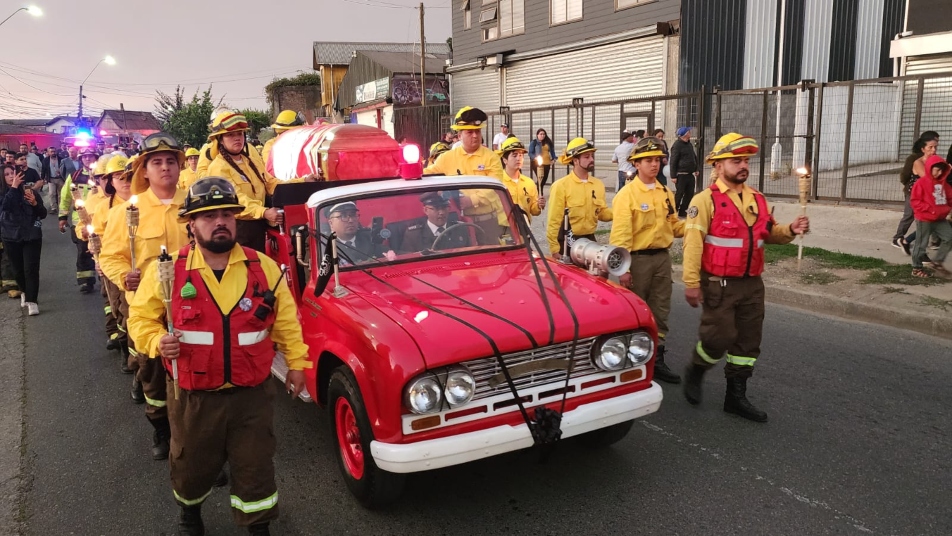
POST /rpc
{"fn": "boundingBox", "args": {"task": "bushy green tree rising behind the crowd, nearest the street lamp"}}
[155,86,221,147]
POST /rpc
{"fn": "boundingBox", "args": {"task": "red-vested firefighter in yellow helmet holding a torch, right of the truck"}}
[684,132,810,422]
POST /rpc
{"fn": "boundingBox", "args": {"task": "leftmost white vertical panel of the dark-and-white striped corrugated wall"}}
[744,1,777,88]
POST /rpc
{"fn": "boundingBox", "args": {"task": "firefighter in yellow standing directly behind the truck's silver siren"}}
[546,138,612,259]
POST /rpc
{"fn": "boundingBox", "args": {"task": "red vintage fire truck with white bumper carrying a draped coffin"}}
[267,124,662,507]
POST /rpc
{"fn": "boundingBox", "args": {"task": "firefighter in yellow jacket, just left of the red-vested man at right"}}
[608,138,684,383]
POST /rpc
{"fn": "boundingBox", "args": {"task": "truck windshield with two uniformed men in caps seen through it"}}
[317,188,524,268]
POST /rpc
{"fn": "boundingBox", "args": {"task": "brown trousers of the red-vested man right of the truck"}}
[692,273,764,378]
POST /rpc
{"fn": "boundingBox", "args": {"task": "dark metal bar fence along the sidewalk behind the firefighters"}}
[442,73,952,203]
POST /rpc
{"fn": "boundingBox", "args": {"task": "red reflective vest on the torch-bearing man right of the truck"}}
[701,183,773,277]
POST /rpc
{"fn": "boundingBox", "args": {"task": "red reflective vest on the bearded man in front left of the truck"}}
[167,246,275,391]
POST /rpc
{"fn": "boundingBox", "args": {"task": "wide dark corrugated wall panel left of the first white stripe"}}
[678,0,747,93]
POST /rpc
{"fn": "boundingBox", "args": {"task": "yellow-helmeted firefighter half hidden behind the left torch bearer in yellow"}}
[93,155,139,376]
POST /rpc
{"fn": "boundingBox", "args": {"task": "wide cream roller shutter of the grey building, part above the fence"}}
[505,36,665,110]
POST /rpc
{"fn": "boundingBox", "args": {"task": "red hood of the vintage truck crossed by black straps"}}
[341,251,653,368]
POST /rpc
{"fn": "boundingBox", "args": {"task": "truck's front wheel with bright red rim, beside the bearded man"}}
[327,367,406,508]
